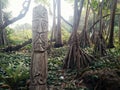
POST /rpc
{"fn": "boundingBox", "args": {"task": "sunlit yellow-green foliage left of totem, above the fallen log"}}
[7,25,32,45]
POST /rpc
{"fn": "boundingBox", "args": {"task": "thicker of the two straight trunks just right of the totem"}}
[55,0,63,47]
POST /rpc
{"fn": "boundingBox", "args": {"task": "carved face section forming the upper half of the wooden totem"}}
[32,5,48,51]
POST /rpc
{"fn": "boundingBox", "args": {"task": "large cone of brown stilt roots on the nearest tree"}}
[63,40,94,70]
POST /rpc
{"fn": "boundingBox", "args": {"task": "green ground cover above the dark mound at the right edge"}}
[91,48,120,69]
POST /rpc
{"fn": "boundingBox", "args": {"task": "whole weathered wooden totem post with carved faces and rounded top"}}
[29,5,48,90]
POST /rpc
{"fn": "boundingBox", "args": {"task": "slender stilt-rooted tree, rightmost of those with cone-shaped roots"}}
[94,1,107,56]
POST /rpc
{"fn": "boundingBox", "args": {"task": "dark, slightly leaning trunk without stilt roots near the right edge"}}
[107,0,117,48]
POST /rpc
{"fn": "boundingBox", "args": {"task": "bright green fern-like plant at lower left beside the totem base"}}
[1,62,29,90]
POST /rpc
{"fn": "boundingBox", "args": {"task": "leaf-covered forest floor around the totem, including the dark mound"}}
[0,47,120,90]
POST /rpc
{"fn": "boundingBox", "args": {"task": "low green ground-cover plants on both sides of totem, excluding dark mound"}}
[0,46,120,90]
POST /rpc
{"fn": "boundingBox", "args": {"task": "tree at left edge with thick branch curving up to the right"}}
[0,0,31,45]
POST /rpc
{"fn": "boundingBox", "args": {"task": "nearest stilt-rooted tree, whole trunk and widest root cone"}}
[63,0,94,70]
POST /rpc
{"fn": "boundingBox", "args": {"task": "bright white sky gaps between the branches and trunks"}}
[8,0,73,27]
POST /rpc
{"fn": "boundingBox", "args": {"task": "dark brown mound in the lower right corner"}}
[80,68,120,90]
